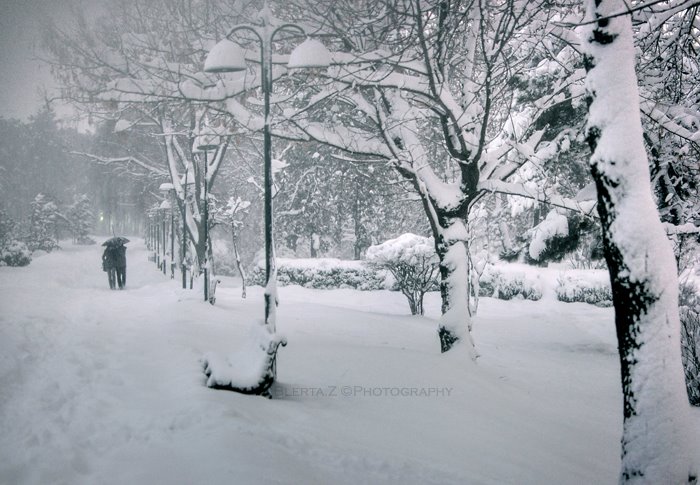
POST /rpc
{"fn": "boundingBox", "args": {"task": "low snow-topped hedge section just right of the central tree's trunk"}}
[479,265,542,301]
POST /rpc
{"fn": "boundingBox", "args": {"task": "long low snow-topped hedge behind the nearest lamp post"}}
[248,258,388,291]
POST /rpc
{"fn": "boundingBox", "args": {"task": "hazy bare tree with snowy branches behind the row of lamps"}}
[45,0,246,278]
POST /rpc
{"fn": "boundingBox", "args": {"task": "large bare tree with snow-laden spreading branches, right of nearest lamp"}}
[274,0,590,352]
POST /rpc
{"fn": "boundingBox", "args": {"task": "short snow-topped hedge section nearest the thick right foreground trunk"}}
[555,270,612,306]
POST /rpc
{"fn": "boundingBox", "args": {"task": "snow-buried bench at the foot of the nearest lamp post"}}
[202,325,287,398]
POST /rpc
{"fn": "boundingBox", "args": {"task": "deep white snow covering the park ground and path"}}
[0,237,688,484]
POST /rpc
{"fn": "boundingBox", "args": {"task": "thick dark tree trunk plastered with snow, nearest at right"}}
[583,0,698,484]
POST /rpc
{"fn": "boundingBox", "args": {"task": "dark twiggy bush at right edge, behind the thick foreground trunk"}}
[678,284,700,406]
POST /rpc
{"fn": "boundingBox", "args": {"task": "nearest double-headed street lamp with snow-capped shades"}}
[204,8,331,333]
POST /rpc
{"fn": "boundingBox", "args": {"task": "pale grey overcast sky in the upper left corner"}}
[0,0,102,120]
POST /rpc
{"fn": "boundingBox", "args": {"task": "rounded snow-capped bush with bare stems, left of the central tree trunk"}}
[367,233,439,315]
